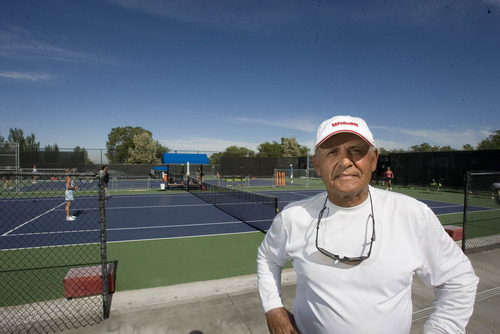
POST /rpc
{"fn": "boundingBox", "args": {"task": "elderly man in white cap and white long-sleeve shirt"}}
[257,116,478,334]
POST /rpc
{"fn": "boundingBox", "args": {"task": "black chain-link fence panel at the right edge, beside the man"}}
[462,172,500,253]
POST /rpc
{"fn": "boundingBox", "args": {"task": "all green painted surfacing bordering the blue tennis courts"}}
[0,183,499,306]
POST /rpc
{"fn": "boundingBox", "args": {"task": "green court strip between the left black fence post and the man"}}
[108,232,264,290]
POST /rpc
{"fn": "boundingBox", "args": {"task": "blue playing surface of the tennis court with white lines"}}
[0,190,487,249]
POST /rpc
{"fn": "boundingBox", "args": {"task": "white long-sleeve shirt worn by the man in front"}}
[257,187,478,334]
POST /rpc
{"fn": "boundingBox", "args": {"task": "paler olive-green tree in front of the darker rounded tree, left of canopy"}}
[125,131,161,165]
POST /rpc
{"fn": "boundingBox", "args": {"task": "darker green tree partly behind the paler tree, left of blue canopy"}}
[106,126,169,163]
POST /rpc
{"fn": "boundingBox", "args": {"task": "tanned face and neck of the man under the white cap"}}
[313,133,378,206]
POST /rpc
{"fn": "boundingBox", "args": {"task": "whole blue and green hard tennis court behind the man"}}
[0,180,494,334]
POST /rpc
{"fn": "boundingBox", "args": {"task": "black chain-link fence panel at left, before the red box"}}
[0,171,109,334]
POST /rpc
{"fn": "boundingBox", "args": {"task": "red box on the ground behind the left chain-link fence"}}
[64,263,115,299]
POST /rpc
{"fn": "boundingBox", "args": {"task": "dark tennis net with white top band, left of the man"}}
[188,177,279,233]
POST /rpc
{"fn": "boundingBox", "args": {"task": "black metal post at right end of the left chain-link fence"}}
[98,169,111,319]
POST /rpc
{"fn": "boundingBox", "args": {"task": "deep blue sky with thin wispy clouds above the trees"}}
[0,0,500,157]
